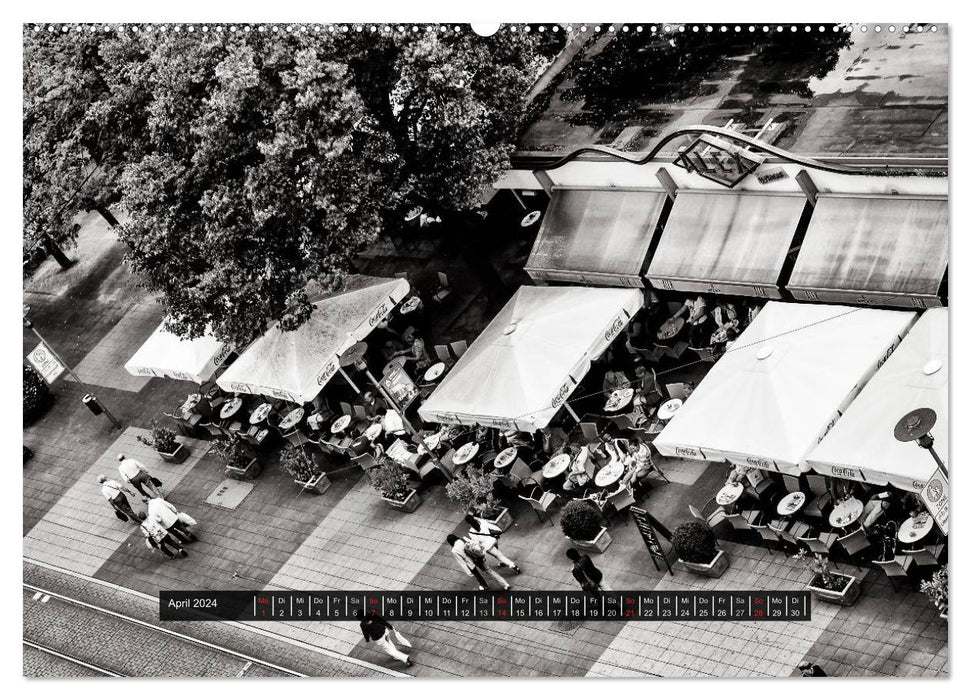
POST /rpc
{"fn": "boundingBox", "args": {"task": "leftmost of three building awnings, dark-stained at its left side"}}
[526,189,667,287]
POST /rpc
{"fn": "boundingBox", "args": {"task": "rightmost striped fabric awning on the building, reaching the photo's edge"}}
[786,195,948,308]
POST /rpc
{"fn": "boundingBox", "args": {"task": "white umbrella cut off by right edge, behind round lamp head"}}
[807,309,950,492]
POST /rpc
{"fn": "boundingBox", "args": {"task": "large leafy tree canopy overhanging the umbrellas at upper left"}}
[24,26,545,344]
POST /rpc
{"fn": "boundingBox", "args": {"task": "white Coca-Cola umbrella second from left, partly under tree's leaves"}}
[216,277,410,403]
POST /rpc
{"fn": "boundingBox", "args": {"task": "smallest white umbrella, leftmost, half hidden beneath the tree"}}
[125,321,233,384]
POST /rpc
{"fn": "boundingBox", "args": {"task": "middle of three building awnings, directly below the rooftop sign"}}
[647,191,807,299]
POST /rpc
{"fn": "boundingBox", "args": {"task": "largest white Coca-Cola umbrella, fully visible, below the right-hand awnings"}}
[654,302,916,475]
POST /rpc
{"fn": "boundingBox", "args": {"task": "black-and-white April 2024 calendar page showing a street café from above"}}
[19,5,962,684]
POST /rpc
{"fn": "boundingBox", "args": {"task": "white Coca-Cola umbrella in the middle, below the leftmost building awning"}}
[418,287,644,432]
